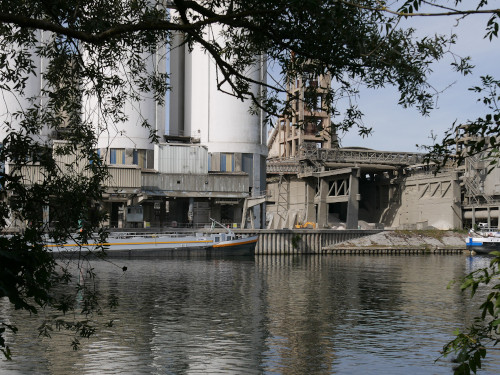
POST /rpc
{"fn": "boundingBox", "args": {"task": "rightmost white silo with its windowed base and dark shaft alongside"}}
[169,26,267,228]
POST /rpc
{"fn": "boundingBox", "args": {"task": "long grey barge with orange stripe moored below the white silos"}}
[45,220,258,257]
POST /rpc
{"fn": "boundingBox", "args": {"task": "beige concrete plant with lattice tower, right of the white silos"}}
[266,77,492,229]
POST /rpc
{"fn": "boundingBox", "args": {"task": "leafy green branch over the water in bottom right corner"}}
[442,252,500,375]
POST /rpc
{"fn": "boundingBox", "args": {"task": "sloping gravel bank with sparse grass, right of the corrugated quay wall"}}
[322,230,468,254]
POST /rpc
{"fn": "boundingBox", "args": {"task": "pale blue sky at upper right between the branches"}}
[340,11,500,152]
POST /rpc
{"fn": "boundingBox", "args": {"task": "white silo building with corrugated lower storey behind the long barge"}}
[0,26,267,228]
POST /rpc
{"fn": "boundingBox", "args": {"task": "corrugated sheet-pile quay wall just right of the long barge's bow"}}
[234,229,382,255]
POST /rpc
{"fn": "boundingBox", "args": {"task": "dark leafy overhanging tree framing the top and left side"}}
[0,0,498,364]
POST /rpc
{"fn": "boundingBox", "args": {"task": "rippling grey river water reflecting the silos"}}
[0,255,500,374]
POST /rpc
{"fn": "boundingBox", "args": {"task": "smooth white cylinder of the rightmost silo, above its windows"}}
[184,37,267,156]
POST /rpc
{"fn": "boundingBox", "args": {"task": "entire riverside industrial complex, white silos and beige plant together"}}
[0,29,500,234]
